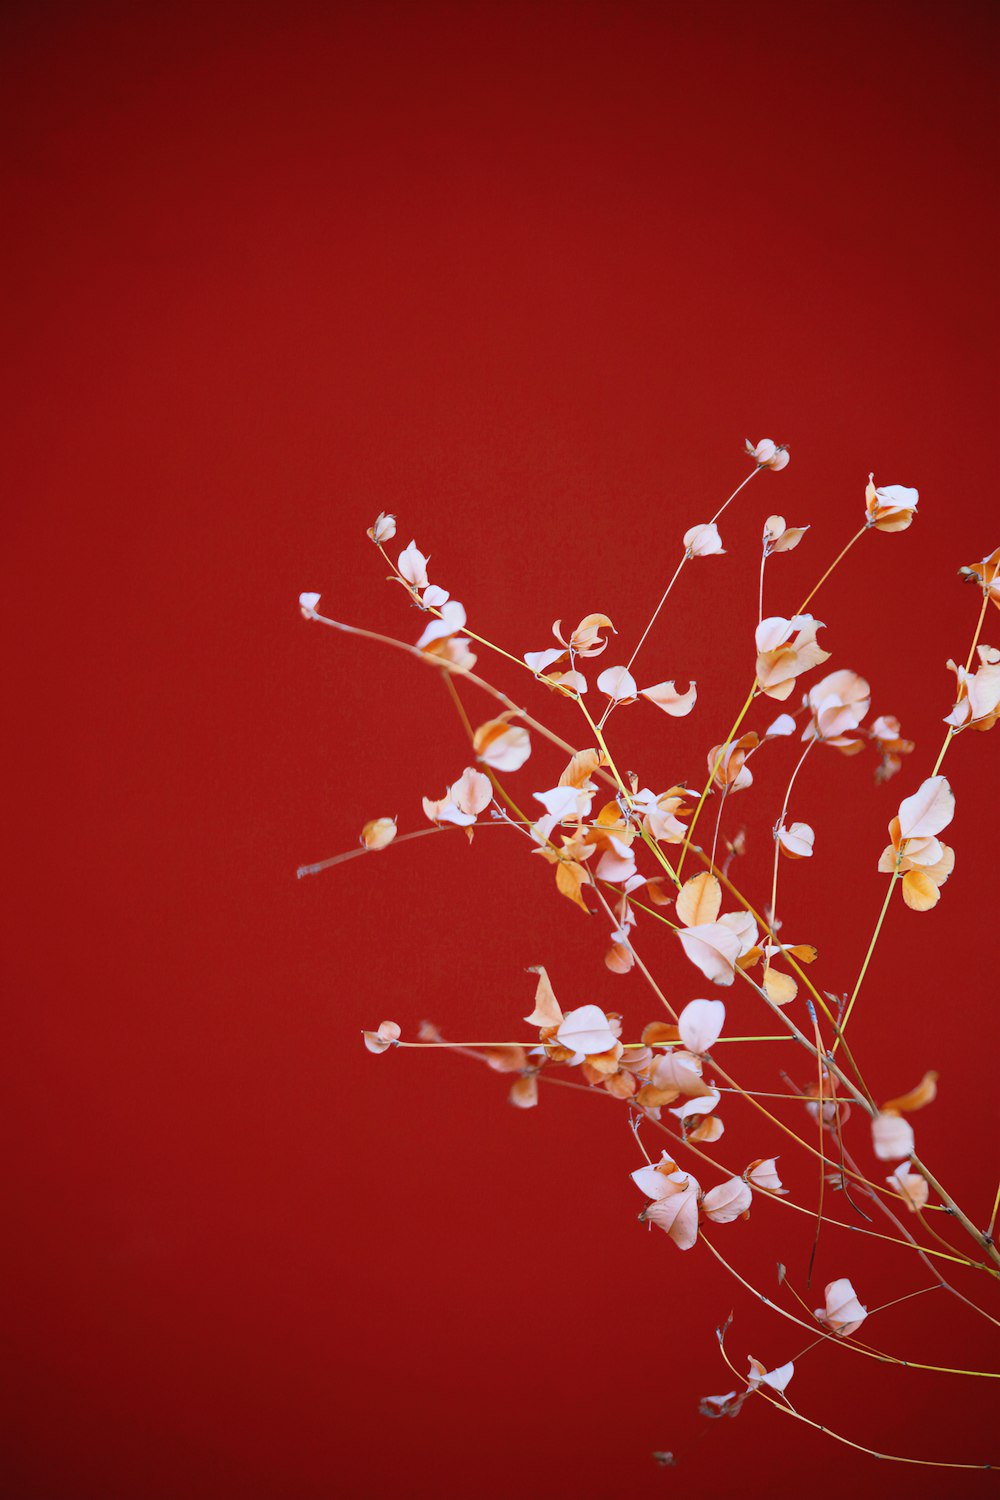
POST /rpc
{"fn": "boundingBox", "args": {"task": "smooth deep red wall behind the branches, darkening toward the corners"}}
[1,3,1000,1500]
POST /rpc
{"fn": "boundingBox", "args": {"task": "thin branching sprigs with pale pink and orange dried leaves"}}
[298,440,1000,1469]
